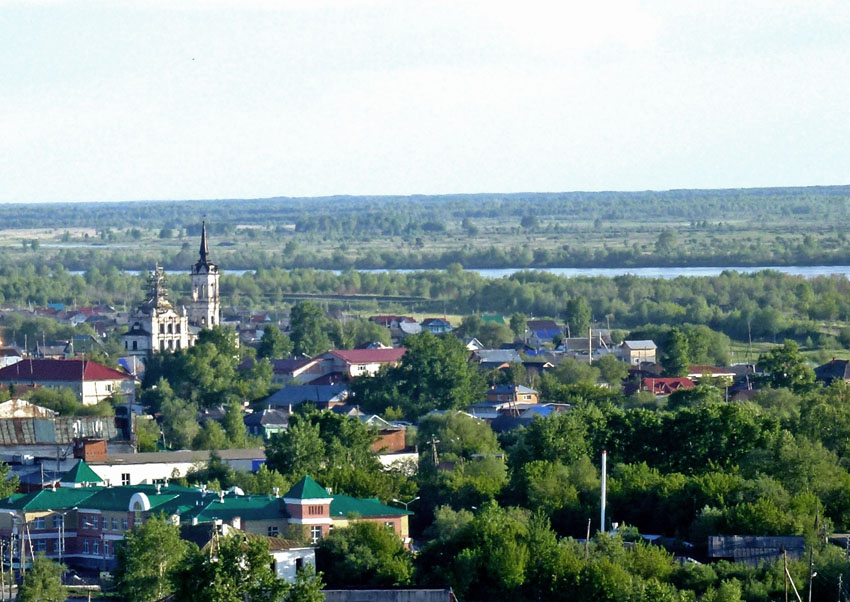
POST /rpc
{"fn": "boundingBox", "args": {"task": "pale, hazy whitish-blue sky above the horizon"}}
[0,0,850,202]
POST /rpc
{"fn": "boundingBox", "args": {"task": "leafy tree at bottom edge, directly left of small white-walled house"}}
[175,533,289,602]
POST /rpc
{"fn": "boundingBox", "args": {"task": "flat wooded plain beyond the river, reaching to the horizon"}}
[0,186,850,270]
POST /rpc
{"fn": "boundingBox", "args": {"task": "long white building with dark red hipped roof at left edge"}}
[0,359,136,405]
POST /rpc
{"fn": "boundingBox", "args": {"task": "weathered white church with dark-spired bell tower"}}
[122,222,221,356]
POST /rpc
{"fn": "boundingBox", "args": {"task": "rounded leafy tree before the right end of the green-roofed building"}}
[316,521,413,586]
